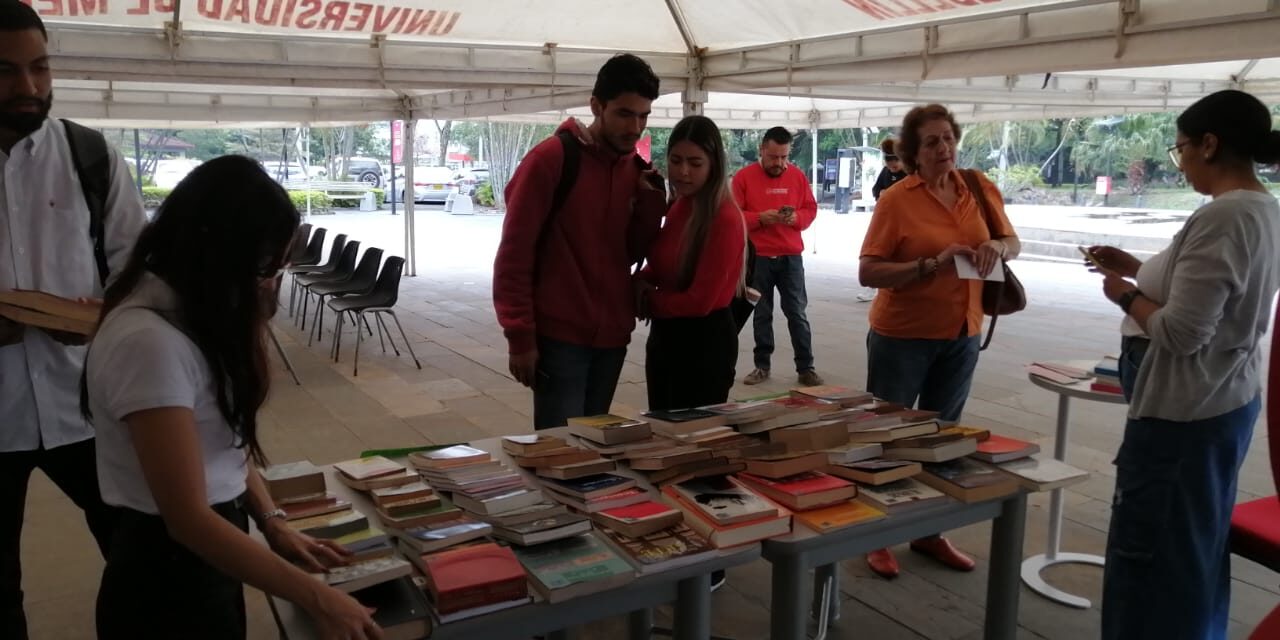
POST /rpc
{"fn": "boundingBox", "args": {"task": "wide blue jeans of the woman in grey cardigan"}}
[1102,397,1262,640]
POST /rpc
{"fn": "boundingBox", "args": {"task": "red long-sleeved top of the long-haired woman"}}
[640,197,746,317]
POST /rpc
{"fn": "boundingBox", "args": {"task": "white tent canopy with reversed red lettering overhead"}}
[37,0,1280,128]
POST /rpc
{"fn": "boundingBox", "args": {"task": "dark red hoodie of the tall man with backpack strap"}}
[493,118,666,353]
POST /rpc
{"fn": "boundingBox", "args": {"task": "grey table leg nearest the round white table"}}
[983,492,1027,640]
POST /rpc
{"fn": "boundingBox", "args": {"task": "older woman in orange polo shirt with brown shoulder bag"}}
[858,105,1021,577]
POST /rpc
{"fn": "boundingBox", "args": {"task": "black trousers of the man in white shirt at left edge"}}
[0,438,114,640]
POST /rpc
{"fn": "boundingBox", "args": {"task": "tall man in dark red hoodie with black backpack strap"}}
[493,54,666,429]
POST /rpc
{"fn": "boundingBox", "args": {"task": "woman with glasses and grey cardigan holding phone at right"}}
[1092,91,1280,640]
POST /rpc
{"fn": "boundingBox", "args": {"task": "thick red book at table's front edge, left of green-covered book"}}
[422,543,527,613]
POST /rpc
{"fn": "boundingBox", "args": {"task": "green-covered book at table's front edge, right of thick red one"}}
[515,534,636,603]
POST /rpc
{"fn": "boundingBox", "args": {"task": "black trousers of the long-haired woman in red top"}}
[644,307,737,411]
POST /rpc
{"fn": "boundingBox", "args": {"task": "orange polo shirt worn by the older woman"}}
[861,172,1016,339]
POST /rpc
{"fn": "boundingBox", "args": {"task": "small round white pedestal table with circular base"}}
[1023,361,1125,609]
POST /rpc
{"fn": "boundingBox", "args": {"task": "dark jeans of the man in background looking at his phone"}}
[751,256,813,371]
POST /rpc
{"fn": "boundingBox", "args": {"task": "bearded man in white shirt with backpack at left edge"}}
[0,0,146,640]
